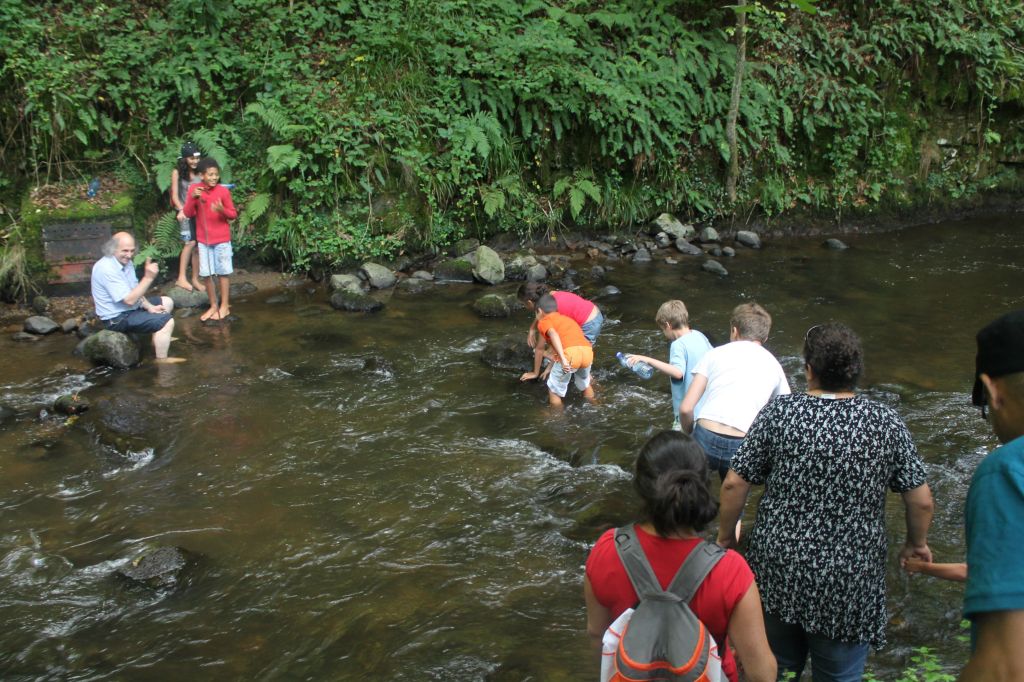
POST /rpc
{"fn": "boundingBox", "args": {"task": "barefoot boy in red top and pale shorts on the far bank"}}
[181,159,239,322]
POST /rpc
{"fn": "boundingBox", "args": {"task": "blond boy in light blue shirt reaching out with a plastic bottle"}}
[626,299,712,431]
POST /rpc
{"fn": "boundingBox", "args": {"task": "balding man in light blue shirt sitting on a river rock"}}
[92,232,184,363]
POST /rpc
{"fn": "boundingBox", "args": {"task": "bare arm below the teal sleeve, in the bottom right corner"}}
[957,609,1024,682]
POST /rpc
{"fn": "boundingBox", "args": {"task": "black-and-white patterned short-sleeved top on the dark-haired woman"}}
[731,393,925,648]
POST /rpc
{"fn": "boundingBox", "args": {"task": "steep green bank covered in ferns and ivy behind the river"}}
[0,0,1024,267]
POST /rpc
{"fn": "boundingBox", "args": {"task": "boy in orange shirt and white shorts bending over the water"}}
[519,294,594,406]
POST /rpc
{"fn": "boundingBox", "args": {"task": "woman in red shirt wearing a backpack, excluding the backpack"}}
[584,431,776,682]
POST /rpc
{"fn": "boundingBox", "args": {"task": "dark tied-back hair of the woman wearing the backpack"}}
[633,431,718,537]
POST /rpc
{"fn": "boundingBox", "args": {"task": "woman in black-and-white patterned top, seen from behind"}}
[718,324,932,682]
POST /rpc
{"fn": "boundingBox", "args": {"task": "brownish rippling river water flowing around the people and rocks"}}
[0,216,1024,681]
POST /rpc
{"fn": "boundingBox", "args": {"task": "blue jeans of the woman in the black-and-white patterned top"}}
[765,611,868,682]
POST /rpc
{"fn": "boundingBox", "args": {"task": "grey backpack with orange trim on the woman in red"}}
[608,525,725,682]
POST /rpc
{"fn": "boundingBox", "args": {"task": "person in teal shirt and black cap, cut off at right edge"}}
[959,309,1024,682]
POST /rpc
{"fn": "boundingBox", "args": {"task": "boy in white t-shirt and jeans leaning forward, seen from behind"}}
[679,303,790,480]
